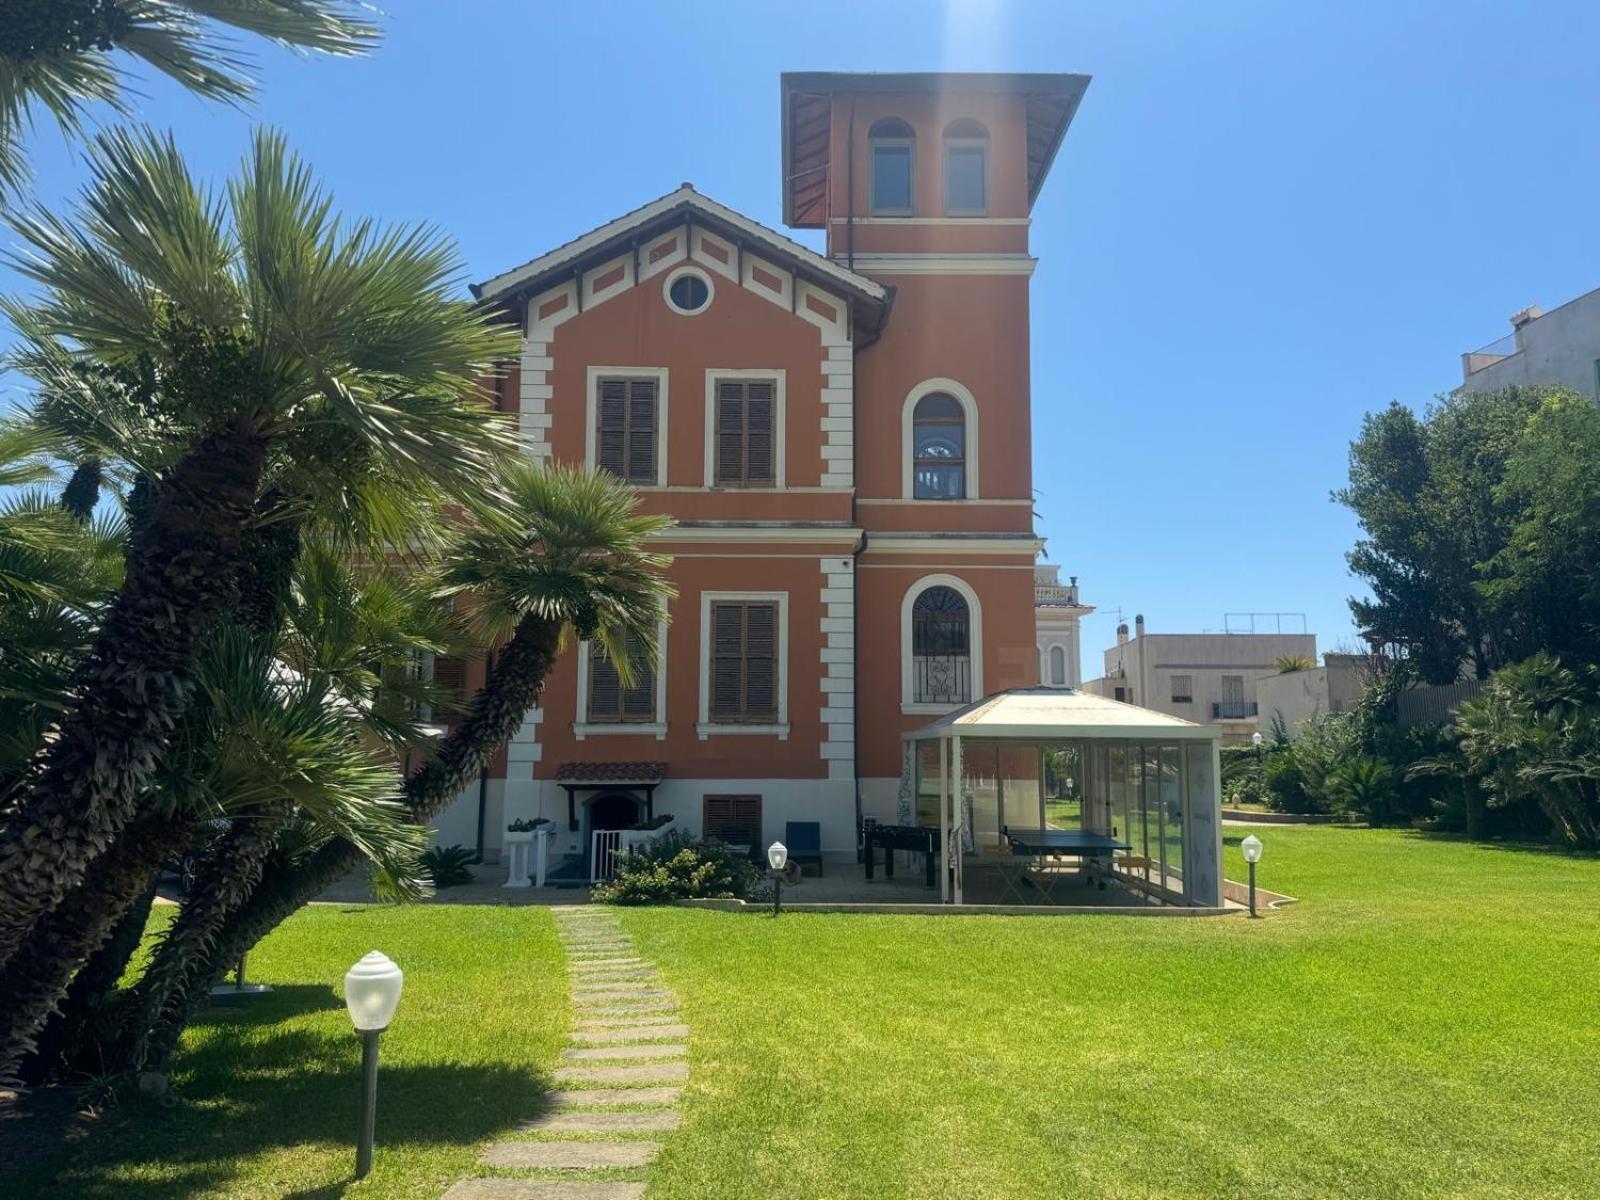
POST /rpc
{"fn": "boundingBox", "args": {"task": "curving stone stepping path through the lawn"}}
[443,906,690,1200]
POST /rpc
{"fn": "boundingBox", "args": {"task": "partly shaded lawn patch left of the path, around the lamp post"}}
[0,906,566,1200]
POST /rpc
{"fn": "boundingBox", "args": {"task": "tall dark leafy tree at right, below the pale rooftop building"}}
[1334,387,1600,683]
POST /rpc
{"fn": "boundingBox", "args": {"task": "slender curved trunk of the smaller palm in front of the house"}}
[144,616,562,1069]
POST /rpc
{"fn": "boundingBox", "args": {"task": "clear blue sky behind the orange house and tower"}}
[12,0,1600,674]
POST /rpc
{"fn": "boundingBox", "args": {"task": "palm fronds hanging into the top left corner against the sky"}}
[0,0,378,198]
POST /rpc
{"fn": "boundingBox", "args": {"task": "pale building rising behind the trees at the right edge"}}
[1461,288,1600,400]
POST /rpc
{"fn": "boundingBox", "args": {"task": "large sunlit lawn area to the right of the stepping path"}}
[624,827,1600,1200]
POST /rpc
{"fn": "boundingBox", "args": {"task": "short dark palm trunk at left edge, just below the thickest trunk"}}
[0,816,186,1082]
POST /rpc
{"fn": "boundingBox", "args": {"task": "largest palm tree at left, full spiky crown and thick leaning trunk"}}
[0,131,515,968]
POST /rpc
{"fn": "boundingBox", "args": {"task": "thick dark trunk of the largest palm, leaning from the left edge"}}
[0,419,267,972]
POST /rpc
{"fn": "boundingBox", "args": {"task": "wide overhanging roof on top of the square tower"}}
[782,70,1090,229]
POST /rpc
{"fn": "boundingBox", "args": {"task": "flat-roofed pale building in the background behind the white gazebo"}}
[1083,616,1317,741]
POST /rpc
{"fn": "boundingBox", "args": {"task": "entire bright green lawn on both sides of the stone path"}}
[12,827,1600,1200]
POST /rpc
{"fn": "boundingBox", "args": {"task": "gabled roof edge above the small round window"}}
[472,184,890,325]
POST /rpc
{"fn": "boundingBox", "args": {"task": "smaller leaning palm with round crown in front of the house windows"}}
[147,461,674,1066]
